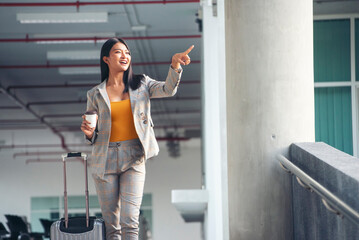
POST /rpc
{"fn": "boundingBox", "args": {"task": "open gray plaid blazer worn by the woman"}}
[85,67,182,178]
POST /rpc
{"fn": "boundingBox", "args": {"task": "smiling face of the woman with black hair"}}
[103,42,131,72]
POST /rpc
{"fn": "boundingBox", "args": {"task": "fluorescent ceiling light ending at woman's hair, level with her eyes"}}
[47,50,100,60]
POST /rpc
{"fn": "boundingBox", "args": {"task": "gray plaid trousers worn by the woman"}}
[94,139,146,240]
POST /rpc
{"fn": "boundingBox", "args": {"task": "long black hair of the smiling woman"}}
[100,37,144,93]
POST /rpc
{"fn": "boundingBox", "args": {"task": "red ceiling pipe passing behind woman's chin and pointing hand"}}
[0,60,201,69]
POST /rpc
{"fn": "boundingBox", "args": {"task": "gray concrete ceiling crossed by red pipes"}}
[0,0,359,144]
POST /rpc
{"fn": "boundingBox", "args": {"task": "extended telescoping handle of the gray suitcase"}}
[62,152,90,228]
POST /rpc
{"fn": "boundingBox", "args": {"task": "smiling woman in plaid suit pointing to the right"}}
[81,38,194,240]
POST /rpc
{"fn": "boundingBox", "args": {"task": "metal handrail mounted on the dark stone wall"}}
[277,155,359,225]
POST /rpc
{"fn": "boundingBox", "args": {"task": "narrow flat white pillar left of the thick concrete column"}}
[202,0,229,240]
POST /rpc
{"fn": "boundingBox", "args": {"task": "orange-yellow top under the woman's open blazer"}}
[110,99,138,142]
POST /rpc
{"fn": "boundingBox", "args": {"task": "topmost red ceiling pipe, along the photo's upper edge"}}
[0,0,200,9]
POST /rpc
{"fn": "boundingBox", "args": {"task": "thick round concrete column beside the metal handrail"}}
[228,0,314,240]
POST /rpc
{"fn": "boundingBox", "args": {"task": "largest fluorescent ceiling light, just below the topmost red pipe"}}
[16,12,108,23]
